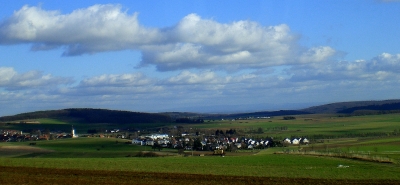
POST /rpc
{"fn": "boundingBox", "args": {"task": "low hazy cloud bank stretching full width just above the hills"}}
[0,53,400,112]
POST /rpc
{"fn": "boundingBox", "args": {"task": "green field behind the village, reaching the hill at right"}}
[198,114,400,138]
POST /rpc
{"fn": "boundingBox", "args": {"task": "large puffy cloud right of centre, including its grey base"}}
[142,14,316,71]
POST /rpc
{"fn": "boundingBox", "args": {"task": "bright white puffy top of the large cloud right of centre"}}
[171,14,295,53]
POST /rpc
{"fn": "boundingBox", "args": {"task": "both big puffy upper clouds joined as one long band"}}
[0,4,336,71]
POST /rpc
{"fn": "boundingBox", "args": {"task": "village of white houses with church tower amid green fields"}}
[0,126,310,152]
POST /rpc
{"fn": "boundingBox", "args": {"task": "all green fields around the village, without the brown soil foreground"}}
[0,114,400,184]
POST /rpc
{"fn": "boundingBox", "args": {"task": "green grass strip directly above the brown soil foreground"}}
[0,150,400,180]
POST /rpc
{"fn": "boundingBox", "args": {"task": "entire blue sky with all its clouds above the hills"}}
[0,0,400,116]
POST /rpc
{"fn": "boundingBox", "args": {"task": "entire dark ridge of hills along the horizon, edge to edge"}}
[0,100,400,124]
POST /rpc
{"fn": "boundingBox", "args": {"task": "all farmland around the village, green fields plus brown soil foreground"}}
[0,114,400,184]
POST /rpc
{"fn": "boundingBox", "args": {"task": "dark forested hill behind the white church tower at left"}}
[0,108,172,123]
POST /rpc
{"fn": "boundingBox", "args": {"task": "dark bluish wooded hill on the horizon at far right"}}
[300,100,400,114]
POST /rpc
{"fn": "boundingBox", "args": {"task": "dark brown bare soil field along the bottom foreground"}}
[0,166,400,185]
